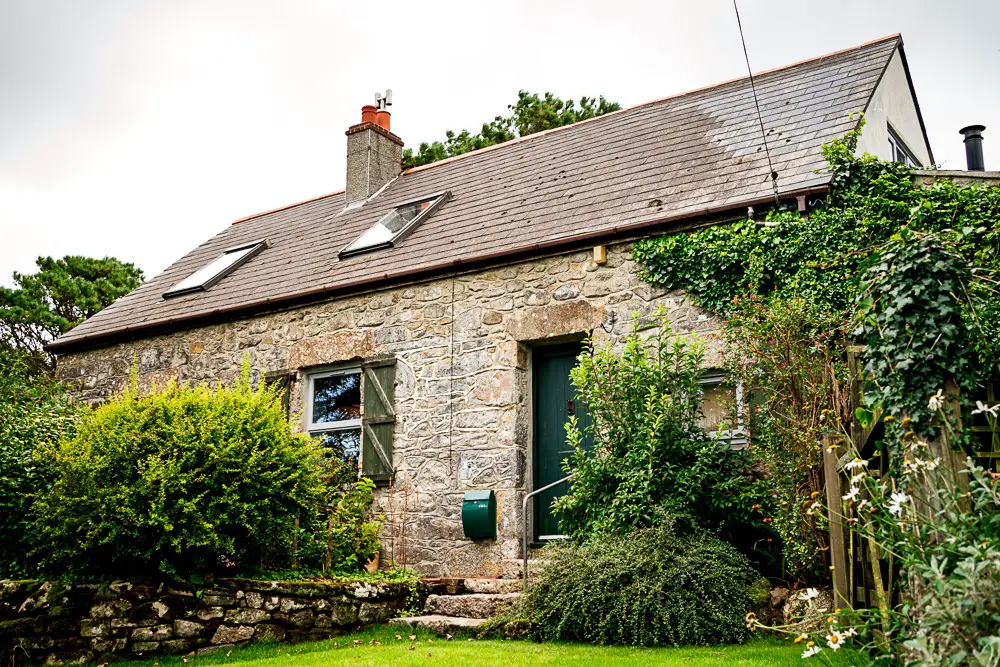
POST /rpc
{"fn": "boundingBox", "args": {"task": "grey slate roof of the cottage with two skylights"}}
[50,35,902,352]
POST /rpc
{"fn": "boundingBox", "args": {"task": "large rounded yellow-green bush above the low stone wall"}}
[33,366,324,576]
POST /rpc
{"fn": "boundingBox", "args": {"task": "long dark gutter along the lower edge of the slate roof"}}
[45,184,830,354]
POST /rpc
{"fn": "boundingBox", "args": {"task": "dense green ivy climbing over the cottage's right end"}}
[634,127,1000,440]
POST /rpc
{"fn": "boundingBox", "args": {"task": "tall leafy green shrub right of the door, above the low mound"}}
[556,312,756,538]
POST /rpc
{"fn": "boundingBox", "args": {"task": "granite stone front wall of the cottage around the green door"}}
[58,244,719,576]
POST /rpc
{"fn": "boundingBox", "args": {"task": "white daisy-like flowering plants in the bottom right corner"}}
[751,391,1000,666]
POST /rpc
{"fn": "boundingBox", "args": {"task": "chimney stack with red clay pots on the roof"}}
[346,105,403,204]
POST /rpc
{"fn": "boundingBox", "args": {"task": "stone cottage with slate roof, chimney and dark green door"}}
[50,35,933,575]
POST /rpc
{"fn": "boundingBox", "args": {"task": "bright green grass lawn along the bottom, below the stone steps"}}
[107,627,866,667]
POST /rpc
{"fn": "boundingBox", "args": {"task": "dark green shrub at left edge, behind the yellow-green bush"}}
[0,350,82,579]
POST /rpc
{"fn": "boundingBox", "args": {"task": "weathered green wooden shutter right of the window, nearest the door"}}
[361,359,396,481]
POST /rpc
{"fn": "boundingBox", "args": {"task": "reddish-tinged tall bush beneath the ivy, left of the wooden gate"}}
[723,296,850,583]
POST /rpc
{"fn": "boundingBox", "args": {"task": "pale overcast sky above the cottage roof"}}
[0,0,1000,284]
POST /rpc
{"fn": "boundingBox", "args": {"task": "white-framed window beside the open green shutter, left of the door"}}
[305,366,362,463]
